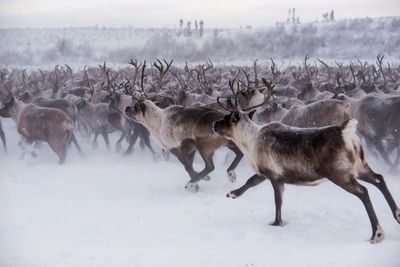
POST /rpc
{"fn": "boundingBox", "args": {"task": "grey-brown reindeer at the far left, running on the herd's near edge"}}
[0,97,81,164]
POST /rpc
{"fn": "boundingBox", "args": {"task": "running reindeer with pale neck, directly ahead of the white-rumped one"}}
[125,78,243,192]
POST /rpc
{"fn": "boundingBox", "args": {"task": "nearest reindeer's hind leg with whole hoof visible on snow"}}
[330,176,384,243]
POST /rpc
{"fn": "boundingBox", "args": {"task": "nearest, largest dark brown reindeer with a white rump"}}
[213,78,400,243]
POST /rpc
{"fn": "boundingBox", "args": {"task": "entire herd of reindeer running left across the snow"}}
[0,55,400,243]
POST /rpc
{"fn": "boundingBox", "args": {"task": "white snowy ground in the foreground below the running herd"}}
[0,119,400,267]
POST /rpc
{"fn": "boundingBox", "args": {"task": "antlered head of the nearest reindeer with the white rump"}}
[213,78,274,138]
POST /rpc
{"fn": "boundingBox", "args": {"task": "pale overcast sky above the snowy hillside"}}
[0,0,400,27]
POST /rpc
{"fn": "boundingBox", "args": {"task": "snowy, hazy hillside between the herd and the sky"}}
[0,17,400,68]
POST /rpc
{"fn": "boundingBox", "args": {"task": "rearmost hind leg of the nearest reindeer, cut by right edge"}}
[358,168,400,223]
